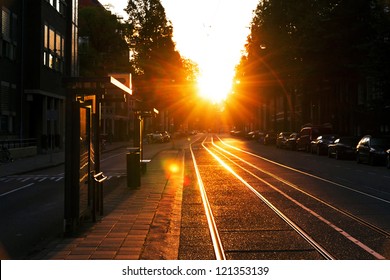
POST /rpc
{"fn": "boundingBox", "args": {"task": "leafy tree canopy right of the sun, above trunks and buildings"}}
[235,0,390,132]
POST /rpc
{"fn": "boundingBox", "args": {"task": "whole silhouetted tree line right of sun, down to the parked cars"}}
[231,0,390,134]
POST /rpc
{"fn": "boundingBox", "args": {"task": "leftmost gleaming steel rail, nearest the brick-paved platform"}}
[190,138,226,260]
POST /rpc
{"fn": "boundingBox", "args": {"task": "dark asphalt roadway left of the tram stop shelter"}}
[0,166,64,259]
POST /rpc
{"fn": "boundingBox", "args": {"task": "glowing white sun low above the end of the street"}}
[197,70,231,103]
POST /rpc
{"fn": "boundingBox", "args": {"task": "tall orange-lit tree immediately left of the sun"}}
[126,0,195,131]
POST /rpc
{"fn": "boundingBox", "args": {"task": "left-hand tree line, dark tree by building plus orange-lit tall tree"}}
[79,0,197,132]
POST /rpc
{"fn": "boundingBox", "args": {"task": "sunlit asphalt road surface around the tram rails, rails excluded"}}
[180,137,390,259]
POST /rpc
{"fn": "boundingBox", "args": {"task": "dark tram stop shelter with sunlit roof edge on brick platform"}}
[64,76,132,234]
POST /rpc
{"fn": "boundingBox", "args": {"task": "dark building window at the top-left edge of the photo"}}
[1,8,18,60]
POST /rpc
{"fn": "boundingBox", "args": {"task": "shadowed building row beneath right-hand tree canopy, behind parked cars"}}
[230,77,390,136]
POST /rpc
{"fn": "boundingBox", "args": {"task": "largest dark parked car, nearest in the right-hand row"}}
[356,135,390,165]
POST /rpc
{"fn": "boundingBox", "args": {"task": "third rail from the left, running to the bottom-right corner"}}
[209,139,386,260]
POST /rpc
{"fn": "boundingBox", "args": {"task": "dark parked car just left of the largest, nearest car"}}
[328,136,359,159]
